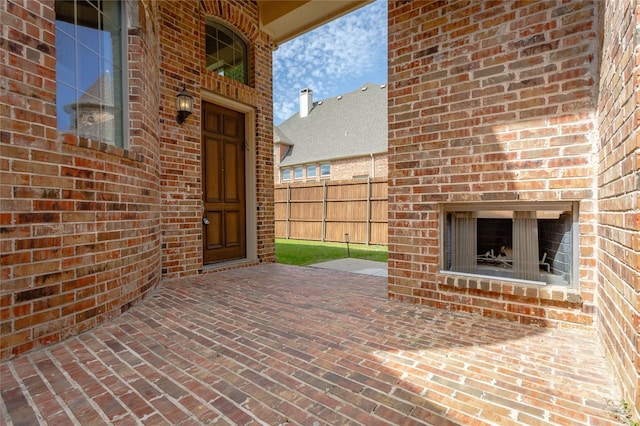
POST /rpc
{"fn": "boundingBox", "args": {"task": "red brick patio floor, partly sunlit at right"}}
[0,264,620,426]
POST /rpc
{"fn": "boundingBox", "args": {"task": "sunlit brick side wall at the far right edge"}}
[597,1,640,419]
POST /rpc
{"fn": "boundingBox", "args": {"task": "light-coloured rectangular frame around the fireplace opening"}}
[439,201,580,290]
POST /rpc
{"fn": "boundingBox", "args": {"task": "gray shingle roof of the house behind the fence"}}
[274,83,388,166]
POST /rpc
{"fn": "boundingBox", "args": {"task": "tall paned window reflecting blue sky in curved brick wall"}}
[55,0,126,146]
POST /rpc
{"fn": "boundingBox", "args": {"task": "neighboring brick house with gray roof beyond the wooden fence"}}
[274,83,388,184]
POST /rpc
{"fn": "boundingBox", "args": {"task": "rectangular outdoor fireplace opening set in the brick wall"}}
[442,202,578,286]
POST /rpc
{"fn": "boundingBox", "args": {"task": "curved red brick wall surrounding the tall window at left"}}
[0,0,160,359]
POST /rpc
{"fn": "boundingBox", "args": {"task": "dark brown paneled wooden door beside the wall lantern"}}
[202,102,246,264]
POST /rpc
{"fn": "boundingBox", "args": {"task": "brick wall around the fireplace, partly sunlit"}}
[389,1,598,327]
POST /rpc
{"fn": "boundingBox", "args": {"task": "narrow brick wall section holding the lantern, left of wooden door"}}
[158,1,204,277]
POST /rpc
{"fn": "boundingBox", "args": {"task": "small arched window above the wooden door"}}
[205,20,248,84]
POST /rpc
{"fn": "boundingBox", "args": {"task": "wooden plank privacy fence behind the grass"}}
[274,178,388,245]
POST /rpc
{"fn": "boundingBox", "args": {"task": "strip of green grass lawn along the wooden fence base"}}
[276,239,388,266]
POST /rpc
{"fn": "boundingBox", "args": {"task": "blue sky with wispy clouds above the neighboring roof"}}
[273,0,387,125]
